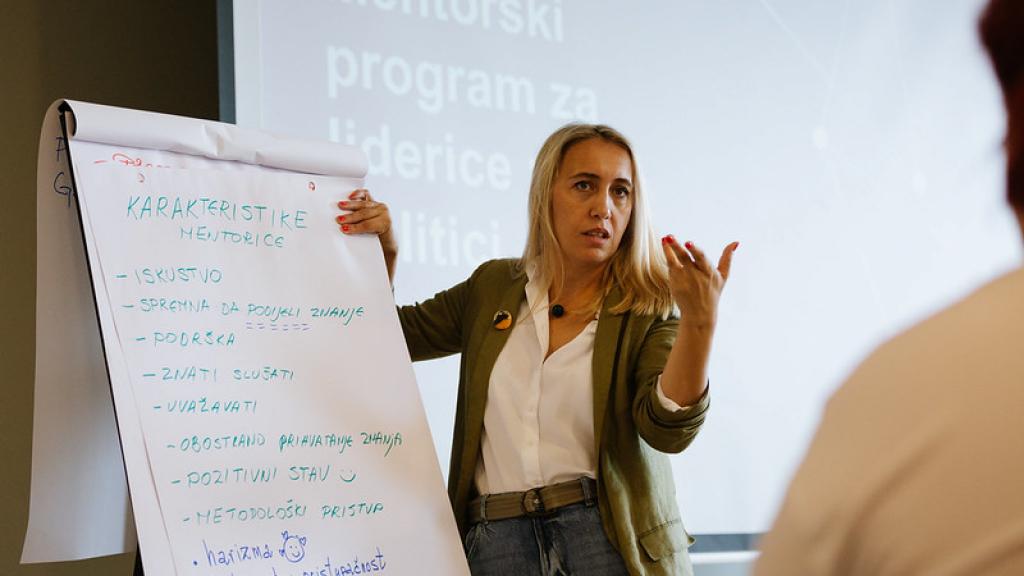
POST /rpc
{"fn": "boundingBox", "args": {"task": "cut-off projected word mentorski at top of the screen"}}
[341,0,565,42]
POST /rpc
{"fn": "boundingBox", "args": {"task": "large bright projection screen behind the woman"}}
[233,0,1020,549]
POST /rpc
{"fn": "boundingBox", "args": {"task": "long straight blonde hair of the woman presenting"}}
[519,123,674,317]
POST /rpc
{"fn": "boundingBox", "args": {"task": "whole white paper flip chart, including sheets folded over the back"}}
[23,102,467,576]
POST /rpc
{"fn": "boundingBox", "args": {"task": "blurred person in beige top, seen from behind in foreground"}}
[754,0,1024,576]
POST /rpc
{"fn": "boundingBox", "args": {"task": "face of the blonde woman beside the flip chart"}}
[551,138,633,270]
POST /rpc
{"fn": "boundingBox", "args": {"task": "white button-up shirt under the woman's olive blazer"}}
[476,270,681,494]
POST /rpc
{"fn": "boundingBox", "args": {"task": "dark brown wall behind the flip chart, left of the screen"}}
[0,0,218,576]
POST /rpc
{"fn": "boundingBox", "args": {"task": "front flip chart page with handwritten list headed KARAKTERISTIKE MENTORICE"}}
[75,143,467,576]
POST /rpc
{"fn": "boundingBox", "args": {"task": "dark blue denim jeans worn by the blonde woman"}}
[464,503,629,576]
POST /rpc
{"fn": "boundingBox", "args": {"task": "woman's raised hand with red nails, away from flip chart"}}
[662,235,739,329]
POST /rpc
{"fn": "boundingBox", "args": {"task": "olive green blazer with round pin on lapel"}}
[398,259,709,575]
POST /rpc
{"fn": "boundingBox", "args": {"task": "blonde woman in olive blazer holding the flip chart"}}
[338,124,738,575]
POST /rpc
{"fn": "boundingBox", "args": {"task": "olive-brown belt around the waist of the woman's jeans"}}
[466,477,597,525]
